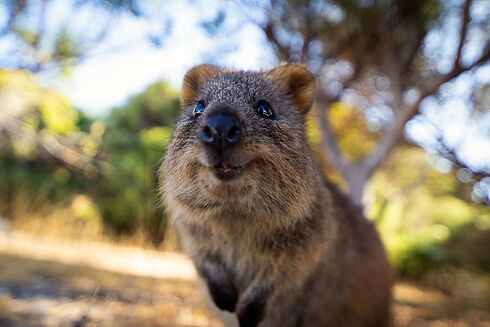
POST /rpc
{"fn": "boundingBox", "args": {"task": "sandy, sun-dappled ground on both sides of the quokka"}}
[0,232,490,327]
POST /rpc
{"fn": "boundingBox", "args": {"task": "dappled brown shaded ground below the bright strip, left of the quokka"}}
[0,255,219,327]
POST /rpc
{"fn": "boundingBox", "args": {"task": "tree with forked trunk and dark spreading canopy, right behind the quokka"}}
[242,0,490,206]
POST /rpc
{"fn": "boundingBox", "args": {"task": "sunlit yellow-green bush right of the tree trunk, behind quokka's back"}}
[367,146,490,277]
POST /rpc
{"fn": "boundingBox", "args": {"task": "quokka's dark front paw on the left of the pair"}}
[197,255,238,312]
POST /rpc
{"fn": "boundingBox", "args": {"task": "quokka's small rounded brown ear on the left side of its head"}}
[181,64,221,105]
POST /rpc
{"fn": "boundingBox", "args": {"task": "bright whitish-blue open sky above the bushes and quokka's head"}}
[48,1,275,117]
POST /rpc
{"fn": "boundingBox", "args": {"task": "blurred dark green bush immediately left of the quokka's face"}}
[97,82,179,244]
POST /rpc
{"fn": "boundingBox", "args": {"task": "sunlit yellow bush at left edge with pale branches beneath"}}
[0,69,103,175]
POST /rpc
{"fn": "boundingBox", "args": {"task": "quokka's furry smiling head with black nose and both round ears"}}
[162,64,315,218]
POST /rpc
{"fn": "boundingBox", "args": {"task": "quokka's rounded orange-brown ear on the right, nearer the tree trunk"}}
[266,64,315,114]
